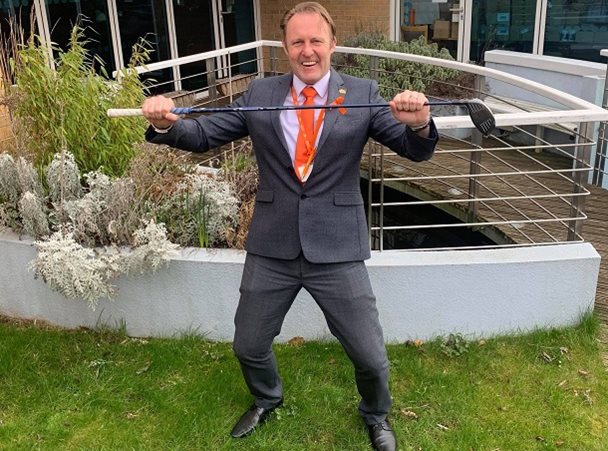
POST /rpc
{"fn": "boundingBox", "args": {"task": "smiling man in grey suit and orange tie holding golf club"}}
[143,2,437,450]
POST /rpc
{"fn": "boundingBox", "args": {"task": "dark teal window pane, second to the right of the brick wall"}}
[470,0,536,61]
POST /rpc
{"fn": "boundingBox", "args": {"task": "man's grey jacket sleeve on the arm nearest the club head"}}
[369,80,439,161]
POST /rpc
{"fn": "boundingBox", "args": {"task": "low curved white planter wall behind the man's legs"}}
[0,235,600,342]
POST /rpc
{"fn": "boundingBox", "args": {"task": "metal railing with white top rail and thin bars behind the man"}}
[122,41,608,250]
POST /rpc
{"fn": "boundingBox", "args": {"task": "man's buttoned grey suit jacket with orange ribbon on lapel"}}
[146,69,437,263]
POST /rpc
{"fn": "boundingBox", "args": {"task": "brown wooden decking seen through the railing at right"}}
[368,140,608,323]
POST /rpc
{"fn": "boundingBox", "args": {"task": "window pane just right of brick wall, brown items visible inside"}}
[400,0,459,58]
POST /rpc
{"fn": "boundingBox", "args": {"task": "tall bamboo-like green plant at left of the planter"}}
[11,27,148,176]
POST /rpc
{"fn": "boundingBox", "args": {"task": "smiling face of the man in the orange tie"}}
[283,13,336,85]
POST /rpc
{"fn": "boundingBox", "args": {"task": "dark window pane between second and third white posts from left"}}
[116,0,174,94]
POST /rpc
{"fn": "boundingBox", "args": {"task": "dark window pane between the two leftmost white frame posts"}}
[45,0,116,73]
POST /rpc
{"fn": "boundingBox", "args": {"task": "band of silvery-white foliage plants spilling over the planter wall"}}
[0,150,245,308]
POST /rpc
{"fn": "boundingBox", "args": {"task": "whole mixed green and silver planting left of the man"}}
[0,23,257,307]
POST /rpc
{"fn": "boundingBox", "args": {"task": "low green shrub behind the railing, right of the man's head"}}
[335,33,468,98]
